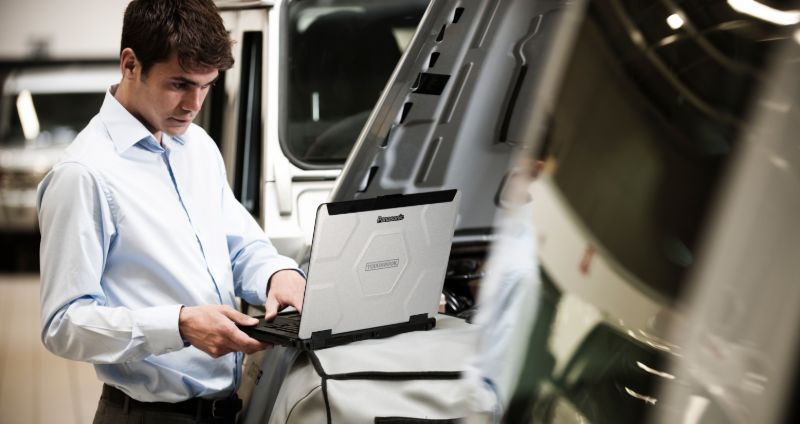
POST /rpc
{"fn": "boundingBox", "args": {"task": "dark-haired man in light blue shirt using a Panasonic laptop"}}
[38,0,305,423]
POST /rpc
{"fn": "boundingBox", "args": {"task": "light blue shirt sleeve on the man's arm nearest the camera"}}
[37,162,183,363]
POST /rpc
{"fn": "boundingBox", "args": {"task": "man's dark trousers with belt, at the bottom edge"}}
[93,385,241,424]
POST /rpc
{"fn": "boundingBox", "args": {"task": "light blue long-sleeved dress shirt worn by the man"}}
[38,87,297,402]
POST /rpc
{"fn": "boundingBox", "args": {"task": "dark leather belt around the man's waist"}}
[100,384,242,419]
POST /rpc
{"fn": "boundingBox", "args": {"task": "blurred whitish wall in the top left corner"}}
[0,0,128,61]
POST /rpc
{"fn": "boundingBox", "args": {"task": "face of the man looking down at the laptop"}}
[130,55,219,139]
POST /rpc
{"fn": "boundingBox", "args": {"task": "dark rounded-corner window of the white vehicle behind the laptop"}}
[280,0,428,168]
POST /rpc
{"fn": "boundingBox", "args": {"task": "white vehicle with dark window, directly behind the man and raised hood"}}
[209,0,428,259]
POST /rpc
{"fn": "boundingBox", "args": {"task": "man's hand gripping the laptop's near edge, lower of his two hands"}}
[178,305,270,358]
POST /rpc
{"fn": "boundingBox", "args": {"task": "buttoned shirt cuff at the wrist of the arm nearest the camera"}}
[137,305,184,355]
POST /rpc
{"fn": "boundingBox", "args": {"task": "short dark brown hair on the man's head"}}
[120,0,233,74]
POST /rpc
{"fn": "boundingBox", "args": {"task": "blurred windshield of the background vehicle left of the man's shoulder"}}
[0,90,105,145]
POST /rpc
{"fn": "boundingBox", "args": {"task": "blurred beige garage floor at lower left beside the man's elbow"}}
[0,274,101,424]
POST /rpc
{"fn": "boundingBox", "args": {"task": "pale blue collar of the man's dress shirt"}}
[100,84,186,154]
